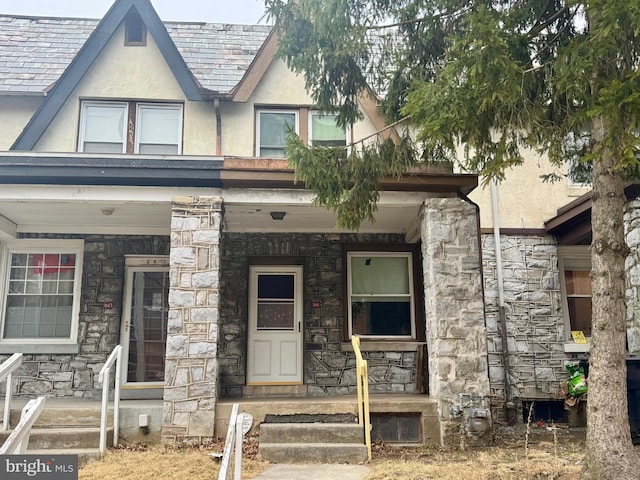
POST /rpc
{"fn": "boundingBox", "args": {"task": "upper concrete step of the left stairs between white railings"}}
[0,427,113,453]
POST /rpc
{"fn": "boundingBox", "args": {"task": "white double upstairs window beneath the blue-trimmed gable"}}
[78,101,182,155]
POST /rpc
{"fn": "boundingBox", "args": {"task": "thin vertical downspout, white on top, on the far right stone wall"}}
[491,180,515,425]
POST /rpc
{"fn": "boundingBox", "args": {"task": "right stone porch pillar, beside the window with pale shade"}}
[421,198,489,444]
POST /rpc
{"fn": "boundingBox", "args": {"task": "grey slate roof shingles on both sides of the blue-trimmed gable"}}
[0,14,272,94]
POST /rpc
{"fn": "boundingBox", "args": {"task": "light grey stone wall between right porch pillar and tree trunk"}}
[482,234,570,402]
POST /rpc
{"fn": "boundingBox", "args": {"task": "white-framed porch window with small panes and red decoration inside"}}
[0,239,84,345]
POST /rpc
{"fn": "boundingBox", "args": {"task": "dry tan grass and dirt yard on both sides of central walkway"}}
[79,425,584,480]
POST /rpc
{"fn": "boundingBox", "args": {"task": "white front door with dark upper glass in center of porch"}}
[247,265,302,385]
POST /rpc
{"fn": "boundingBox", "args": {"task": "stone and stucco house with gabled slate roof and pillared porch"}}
[0,0,489,442]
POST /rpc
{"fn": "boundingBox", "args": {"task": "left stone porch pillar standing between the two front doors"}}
[162,197,222,443]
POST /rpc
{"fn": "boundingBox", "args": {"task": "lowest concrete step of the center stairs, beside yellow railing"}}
[260,442,367,463]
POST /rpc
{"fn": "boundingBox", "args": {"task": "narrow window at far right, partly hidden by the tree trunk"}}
[558,246,591,348]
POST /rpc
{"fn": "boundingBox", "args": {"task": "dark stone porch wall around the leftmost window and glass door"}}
[0,234,169,399]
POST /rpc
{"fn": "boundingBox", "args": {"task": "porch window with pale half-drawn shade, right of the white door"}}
[347,252,416,339]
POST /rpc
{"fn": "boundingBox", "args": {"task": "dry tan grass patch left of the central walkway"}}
[78,438,267,480]
